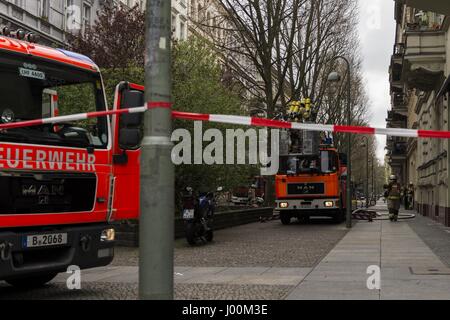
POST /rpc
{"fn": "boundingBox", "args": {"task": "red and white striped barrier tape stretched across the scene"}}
[0,102,450,139]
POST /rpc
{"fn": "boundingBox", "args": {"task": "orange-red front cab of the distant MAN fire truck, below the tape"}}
[275,145,347,224]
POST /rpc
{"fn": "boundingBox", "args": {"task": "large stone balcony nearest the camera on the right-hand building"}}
[403,17,446,91]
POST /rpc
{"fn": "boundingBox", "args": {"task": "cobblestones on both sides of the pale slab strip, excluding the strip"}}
[0,220,347,300]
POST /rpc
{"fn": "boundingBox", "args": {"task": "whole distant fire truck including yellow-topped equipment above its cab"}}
[275,103,346,224]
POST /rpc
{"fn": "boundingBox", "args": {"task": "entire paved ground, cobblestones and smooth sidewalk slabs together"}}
[0,202,450,300]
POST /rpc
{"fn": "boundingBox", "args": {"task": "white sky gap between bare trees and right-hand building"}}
[358,0,395,161]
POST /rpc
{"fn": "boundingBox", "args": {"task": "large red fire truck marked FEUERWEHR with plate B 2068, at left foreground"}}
[0,32,144,286]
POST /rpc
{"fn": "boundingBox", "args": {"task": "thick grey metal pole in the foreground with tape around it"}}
[139,0,175,299]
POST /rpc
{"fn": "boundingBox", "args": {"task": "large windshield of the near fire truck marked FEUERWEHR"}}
[0,53,108,148]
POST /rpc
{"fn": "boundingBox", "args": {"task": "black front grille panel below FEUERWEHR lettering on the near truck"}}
[0,172,97,214]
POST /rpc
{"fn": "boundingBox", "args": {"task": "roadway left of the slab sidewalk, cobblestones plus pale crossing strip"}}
[0,214,347,299]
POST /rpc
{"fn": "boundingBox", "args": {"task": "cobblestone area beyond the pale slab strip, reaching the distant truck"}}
[113,219,347,267]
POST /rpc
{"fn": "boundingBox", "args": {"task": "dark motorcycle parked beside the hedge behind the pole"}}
[182,187,222,245]
